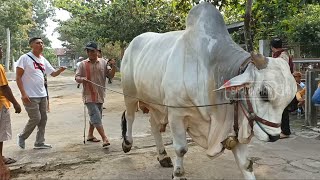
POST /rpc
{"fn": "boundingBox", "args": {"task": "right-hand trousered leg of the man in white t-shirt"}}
[34,97,48,146]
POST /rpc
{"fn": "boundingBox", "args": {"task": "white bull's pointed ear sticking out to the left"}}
[214,64,253,91]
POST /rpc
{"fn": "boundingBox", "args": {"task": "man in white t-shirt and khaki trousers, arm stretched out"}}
[16,37,66,149]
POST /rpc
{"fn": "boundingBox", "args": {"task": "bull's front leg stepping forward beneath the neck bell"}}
[232,143,256,179]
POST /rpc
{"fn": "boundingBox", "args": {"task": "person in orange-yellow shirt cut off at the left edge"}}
[0,44,21,180]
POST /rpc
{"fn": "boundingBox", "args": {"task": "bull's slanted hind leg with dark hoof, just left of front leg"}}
[149,115,172,167]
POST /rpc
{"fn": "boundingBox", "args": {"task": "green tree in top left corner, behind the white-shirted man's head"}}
[0,0,53,67]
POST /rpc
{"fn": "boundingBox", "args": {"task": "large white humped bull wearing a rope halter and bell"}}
[121,3,296,179]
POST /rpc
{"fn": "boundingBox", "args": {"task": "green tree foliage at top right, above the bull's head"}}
[223,0,319,48]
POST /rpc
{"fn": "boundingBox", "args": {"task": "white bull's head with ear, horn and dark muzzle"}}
[219,53,296,141]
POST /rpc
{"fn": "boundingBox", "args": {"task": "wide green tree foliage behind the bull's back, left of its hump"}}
[55,0,191,57]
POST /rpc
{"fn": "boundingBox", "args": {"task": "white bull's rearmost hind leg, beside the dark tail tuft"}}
[121,98,137,153]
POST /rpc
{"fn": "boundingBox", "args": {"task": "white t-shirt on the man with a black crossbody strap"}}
[17,52,55,97]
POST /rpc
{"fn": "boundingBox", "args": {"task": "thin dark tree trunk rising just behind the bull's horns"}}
[244,0,253,52]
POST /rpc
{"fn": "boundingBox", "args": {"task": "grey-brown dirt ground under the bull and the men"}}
[4,72,320,179]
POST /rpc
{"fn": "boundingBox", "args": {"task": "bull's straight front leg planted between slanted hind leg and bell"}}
[169,115,188,180]
